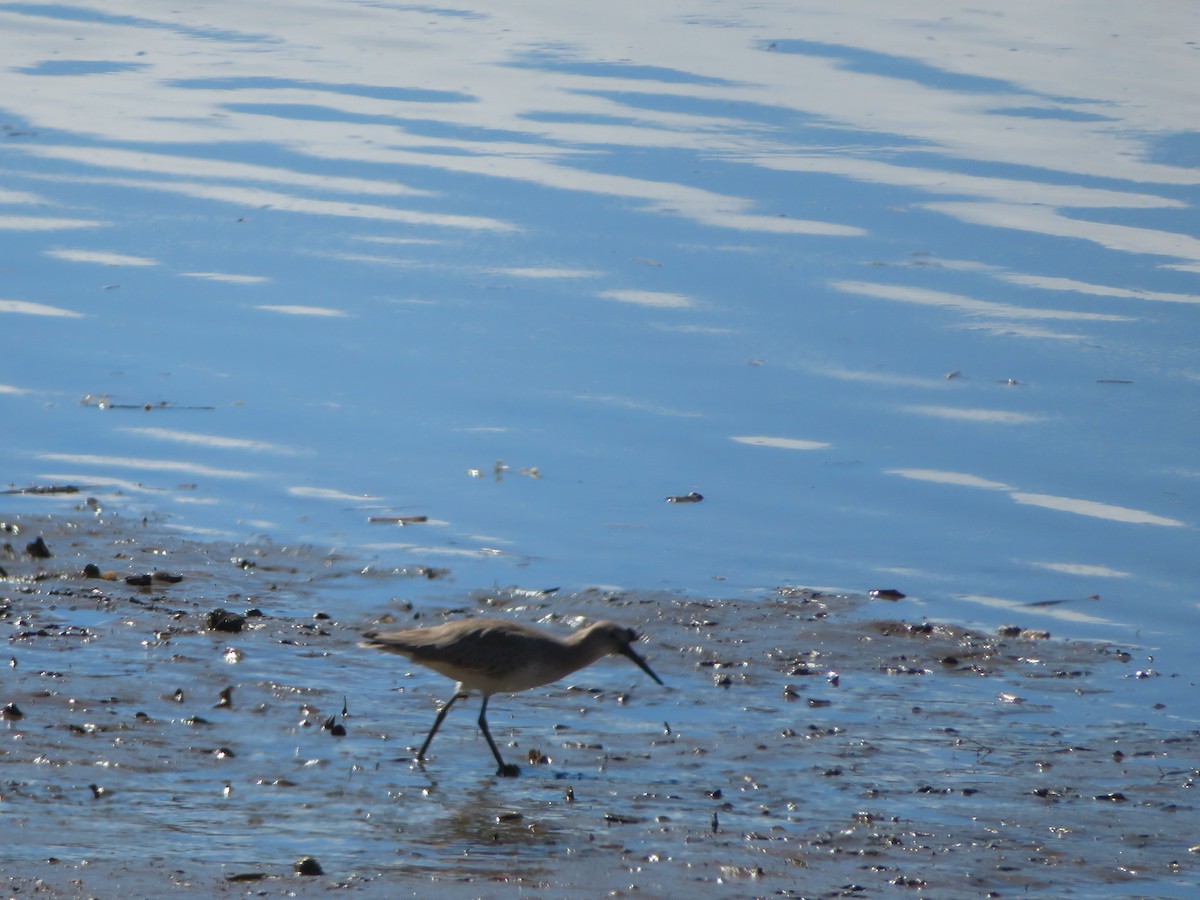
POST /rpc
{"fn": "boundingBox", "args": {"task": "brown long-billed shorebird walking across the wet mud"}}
[359,618,662,775]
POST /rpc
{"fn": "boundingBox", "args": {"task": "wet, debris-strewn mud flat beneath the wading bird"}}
[0,506,1200,898]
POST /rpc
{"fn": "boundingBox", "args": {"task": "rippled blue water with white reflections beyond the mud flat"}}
[0,0,1200,897]
